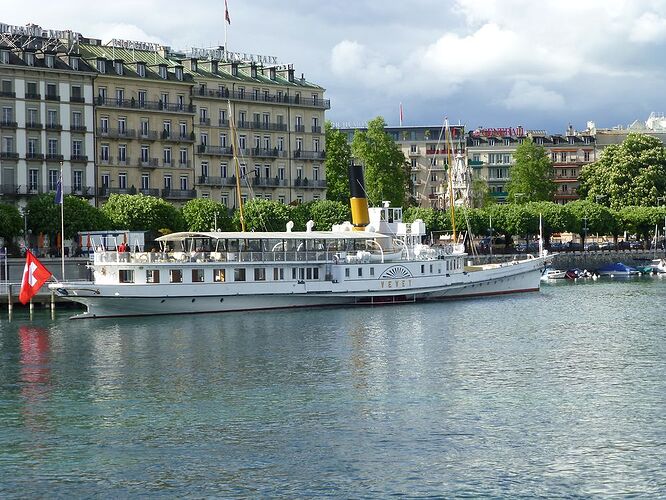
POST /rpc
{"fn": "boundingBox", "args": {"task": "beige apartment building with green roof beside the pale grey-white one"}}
[78,39,196,205]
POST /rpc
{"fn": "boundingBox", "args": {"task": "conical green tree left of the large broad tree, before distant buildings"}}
[506,139,556,203]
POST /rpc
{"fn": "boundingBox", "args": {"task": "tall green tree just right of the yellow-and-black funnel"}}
[352,117,406,207]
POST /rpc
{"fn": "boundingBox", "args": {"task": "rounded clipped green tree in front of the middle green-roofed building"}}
[102,194,185,232]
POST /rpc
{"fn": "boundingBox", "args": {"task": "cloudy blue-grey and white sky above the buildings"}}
[5,0,666,133]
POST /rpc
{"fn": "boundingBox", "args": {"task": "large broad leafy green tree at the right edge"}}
[578,133,666,210]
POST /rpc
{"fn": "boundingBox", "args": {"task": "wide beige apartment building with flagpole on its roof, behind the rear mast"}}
[180,48,330,207]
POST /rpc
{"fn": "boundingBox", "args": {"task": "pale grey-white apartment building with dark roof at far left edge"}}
[0,25,95,207]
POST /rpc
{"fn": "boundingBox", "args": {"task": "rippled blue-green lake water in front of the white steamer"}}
[0,278,666,498]
